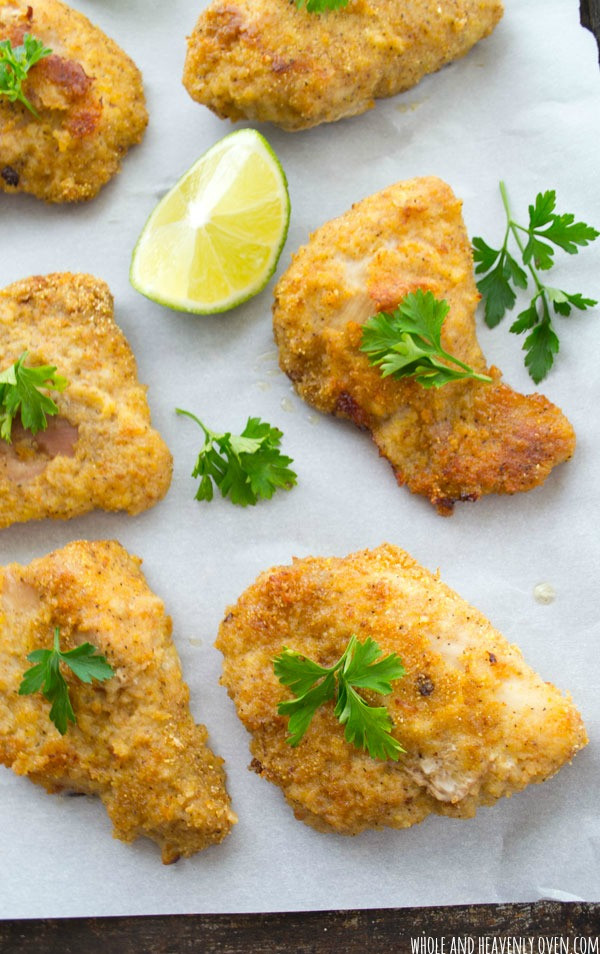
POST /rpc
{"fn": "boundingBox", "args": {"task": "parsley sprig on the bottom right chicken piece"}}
[273,635,405,762]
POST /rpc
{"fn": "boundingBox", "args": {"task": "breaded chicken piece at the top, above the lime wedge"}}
[183,0,502,130]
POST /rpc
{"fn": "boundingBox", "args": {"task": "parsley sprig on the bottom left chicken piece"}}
[19,626,114,735]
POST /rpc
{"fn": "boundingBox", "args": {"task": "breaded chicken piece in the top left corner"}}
[0,0,148,202]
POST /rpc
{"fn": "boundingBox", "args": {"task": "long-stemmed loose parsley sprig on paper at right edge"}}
[473,182,600,384]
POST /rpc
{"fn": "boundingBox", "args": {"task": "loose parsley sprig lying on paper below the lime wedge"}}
[176,408,297,507]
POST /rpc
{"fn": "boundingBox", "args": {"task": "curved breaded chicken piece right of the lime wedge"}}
[273,178,575,515]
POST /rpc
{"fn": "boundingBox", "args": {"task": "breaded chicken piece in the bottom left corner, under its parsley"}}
[0,541,236,864]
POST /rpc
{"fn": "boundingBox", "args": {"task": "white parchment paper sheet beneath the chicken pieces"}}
[0,0,600,918]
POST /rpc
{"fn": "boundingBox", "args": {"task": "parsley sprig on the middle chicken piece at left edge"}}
[0,351,69,444]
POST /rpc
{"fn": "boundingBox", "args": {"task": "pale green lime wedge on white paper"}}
[129,129,290,314]
